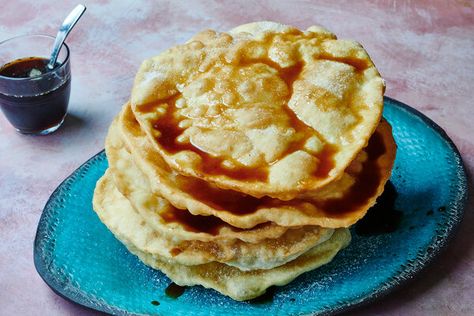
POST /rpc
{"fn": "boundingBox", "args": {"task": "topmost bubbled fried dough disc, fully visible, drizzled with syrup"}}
[131,22,384,200]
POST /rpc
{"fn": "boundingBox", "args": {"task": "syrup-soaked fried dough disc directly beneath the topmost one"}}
[116,105,396,228]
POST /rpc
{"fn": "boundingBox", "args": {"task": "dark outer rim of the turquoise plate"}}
[33,96,469,315]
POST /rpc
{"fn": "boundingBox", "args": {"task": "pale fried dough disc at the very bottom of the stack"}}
[107,218,351,301]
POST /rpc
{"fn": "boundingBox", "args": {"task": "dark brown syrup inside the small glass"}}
[0,57,71,133]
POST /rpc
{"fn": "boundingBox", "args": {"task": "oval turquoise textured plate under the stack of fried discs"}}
[34,98,467,315]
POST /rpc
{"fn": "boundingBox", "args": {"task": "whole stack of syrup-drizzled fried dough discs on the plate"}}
[94,22,396,300]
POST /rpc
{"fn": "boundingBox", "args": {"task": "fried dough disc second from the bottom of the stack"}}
[94,171,333,271]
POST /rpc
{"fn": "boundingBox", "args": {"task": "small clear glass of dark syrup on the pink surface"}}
[0,35,71,135]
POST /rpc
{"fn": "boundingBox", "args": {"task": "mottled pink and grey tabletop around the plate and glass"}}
[0,0,474,315]
